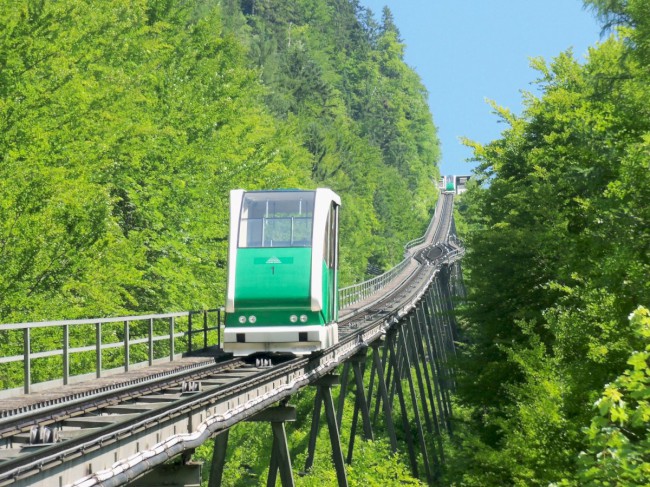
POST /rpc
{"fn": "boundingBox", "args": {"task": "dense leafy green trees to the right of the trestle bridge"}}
[449,0,650,486]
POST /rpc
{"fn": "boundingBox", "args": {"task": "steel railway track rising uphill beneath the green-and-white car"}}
[0,194,460,486]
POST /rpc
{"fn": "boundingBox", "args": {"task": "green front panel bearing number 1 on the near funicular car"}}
[235,248,311,309]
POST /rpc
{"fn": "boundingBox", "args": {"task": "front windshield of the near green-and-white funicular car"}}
[239,191,316,247]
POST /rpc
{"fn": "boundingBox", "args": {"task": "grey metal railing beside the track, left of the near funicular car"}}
[0,308,224,394]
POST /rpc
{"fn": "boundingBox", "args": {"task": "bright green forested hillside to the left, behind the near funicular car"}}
[0,0,439,323]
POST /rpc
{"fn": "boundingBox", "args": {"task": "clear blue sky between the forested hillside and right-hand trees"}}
[360,0,600,178]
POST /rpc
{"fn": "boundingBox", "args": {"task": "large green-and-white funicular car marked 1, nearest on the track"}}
[223,188,341,356]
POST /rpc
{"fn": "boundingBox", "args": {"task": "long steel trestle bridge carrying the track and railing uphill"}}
[0,193,464,487]
